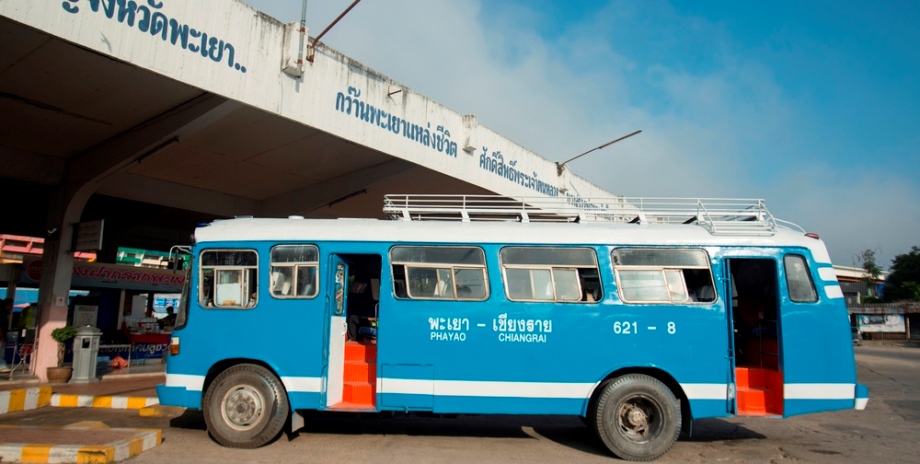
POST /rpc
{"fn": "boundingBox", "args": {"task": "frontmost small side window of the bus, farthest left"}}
[198,250,259,308]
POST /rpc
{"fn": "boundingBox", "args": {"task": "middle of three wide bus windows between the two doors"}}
[501,247,600,302]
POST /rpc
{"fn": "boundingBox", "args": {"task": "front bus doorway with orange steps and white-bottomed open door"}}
[325,254,381,411]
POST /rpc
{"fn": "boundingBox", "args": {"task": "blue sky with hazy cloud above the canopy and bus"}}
[244,0,920,270]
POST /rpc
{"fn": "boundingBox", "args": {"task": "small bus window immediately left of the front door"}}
[270,245,319,298]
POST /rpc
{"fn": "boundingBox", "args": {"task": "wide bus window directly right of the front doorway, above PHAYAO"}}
[390,246,489,300]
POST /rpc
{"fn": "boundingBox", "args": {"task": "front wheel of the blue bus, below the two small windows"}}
[203,364,290,448]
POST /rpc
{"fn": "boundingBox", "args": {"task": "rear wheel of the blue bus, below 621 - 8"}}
[591,374,681,461]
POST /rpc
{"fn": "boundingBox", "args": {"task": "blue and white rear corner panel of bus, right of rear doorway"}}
[780,253,857,416]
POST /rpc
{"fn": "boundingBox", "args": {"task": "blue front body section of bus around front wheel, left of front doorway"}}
[158,242,325,409]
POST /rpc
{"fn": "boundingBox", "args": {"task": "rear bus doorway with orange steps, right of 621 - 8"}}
[726,258,783,416]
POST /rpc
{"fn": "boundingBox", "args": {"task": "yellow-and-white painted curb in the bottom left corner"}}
[0,426,163,464]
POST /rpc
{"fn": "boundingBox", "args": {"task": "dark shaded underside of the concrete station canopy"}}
[0,17,484,249]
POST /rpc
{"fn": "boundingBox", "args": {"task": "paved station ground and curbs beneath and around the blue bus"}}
[0,342,920,463]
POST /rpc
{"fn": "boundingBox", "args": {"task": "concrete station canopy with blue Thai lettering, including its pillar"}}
[0,0,612,378]
